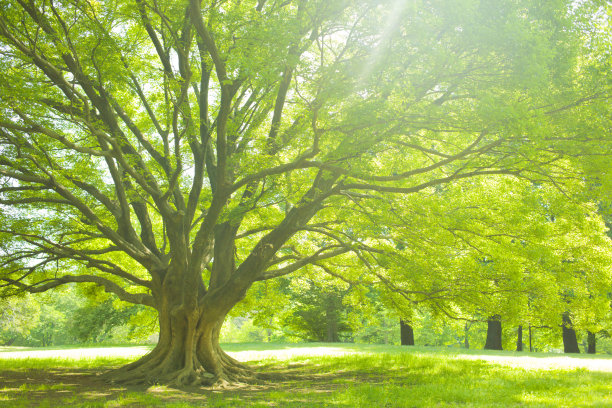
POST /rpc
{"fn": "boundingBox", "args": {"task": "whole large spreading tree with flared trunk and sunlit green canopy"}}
[0,0,610,385]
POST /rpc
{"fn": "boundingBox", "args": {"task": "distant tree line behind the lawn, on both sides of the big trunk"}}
[0,279,612,354]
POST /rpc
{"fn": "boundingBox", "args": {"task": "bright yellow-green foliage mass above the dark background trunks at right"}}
[369,175,612,347]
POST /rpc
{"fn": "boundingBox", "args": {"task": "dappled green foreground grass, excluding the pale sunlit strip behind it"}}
[0,355,612,408]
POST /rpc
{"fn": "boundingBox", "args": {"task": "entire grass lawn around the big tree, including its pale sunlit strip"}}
[0,344,612,408]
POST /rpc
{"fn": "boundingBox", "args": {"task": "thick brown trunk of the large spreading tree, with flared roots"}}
[107,262,253,387]
